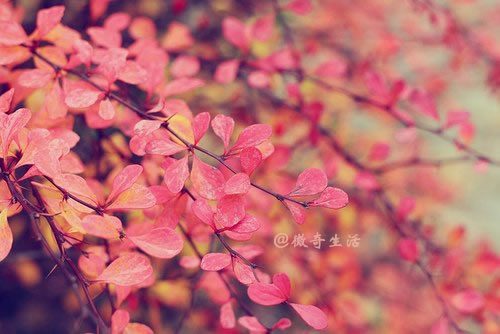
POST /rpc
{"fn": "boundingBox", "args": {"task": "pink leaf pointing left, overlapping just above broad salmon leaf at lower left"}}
[128,227,184,259]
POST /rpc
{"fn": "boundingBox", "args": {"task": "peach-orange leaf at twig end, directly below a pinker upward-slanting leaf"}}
[107,184,156,210]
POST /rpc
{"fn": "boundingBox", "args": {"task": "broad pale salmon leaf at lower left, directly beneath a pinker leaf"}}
[95,252,153,286]
